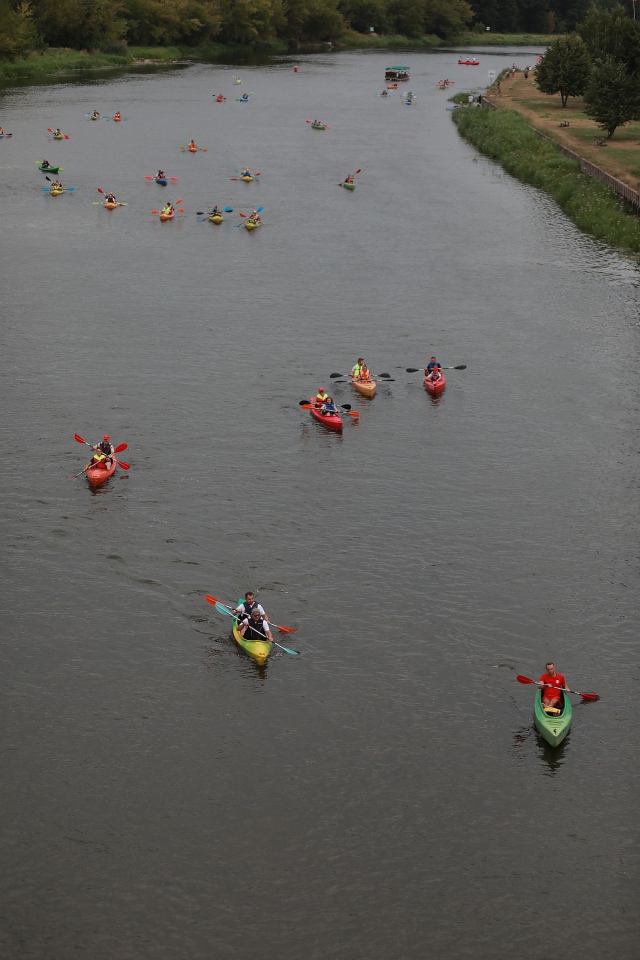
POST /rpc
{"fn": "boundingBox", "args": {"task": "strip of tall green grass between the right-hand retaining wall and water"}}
[452,110,640,254]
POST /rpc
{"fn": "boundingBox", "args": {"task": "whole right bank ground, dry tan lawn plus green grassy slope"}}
[452,71,640,257]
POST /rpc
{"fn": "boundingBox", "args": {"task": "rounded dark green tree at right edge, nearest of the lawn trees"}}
[584,57,640,140]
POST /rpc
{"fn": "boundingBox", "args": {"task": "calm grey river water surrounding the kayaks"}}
[0,50,640,960]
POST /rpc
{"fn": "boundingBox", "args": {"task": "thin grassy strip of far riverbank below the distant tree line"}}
[0,32,552,85]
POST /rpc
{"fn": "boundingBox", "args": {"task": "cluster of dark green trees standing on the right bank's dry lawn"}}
[536,4,640,139]
